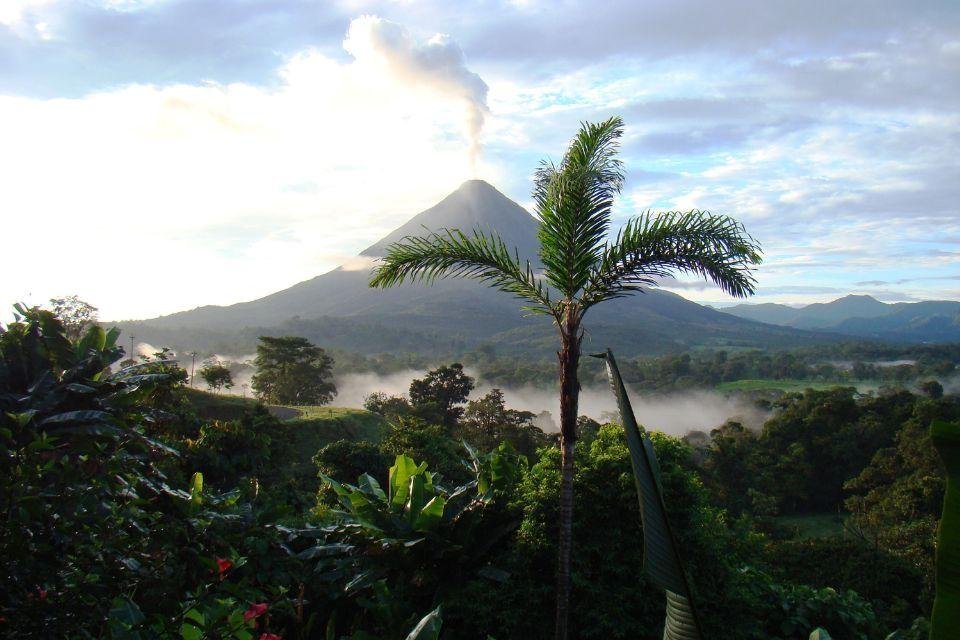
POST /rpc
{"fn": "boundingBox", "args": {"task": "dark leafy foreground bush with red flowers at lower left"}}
[0,307,292,638]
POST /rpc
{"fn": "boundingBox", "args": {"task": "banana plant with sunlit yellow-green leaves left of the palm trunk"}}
[304,445,525,640]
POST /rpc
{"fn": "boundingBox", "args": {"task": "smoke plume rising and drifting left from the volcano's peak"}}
[343,15,489,166]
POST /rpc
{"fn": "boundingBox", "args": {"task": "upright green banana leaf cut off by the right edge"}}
[930,420,960,640]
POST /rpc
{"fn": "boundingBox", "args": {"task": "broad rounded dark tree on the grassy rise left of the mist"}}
[253,336,337,405]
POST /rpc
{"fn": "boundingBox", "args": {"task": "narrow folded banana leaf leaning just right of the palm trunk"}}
[597,349,703,640]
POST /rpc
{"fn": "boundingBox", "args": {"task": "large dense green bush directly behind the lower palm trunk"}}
[444,425,759,640]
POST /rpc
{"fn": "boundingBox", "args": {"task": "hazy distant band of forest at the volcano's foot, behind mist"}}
[110,308,960,391]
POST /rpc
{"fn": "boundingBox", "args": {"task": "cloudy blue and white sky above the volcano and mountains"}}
[0,0,960,319]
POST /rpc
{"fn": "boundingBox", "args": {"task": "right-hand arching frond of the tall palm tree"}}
[582,210,761,309]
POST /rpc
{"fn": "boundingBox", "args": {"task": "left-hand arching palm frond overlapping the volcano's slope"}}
[370,229,556,316]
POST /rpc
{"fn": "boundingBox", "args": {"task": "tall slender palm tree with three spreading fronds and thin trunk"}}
[370,117,760,640]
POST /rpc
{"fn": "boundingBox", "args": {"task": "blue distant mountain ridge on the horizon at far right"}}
[723,295,960,342]
